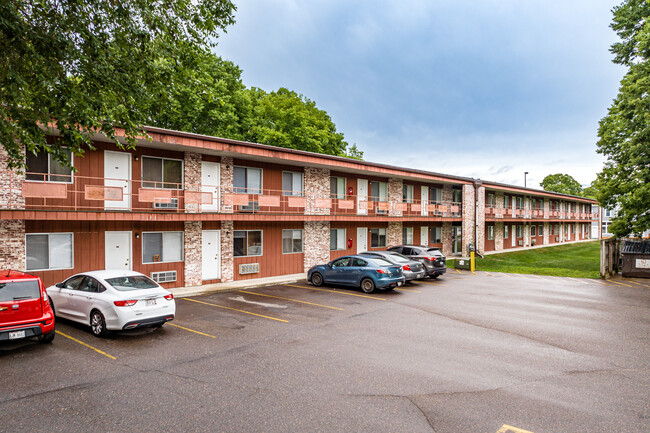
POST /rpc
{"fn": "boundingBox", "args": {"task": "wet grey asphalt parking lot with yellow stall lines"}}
[0,270,650,433]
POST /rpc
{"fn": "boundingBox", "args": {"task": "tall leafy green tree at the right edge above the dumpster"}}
[595,0,650,236]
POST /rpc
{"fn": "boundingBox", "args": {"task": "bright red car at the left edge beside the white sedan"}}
[0,270,55,343]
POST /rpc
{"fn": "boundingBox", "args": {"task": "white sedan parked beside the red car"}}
[46,271,176,337]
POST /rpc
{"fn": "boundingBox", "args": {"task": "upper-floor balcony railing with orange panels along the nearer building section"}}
[0,172,462,218]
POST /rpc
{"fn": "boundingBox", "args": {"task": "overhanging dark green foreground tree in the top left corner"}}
[0,0,235,168]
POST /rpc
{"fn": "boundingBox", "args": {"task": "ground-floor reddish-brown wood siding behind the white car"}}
[25,221,184,288]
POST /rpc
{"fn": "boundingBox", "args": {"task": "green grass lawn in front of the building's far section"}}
[448,241,600,278]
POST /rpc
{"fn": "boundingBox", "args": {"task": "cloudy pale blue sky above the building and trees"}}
[215,0,624,187]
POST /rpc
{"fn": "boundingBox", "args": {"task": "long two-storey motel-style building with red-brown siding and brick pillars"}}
[0,128,597,288]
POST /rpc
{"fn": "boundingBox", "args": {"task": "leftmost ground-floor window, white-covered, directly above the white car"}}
[25,233,74,271]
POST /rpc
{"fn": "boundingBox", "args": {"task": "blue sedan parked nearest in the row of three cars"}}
[307,255,404,293]
